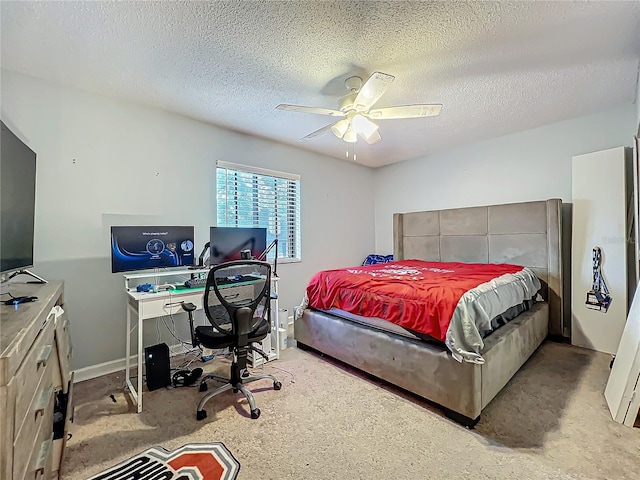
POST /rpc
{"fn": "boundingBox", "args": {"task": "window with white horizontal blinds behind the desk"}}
[216,161,302,260]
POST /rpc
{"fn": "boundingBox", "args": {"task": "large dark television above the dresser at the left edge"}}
[0,122,36,273]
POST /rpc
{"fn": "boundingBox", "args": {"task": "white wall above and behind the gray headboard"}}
[374,105,638,254]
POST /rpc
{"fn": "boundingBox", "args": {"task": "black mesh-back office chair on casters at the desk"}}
[182,260,282,420]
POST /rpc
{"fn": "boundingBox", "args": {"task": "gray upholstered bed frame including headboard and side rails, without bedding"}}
[294,199,563,428]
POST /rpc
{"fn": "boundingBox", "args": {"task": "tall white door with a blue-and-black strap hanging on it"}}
[571,147,627,354]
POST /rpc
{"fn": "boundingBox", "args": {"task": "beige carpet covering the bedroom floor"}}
[63,343,640,480]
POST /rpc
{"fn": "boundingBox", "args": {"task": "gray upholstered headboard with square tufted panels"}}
[393,199,563,335]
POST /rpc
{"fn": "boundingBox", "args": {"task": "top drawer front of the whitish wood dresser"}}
[14,321,58,434]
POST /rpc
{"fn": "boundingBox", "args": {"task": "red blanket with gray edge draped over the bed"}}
[296,260,540,363]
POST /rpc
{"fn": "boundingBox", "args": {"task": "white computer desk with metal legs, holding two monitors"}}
[125,270,280,413]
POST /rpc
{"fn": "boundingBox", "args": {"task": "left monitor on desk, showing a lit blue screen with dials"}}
[111,226,194,273]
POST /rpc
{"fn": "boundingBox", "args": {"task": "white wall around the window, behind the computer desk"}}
[1,70,374,368]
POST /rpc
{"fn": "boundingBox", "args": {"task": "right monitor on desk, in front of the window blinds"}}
[209,227,267,265]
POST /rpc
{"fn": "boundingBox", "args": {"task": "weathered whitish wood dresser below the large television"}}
[0,281,73,480]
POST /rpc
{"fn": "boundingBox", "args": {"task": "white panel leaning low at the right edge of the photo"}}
[604,287,640,427]
